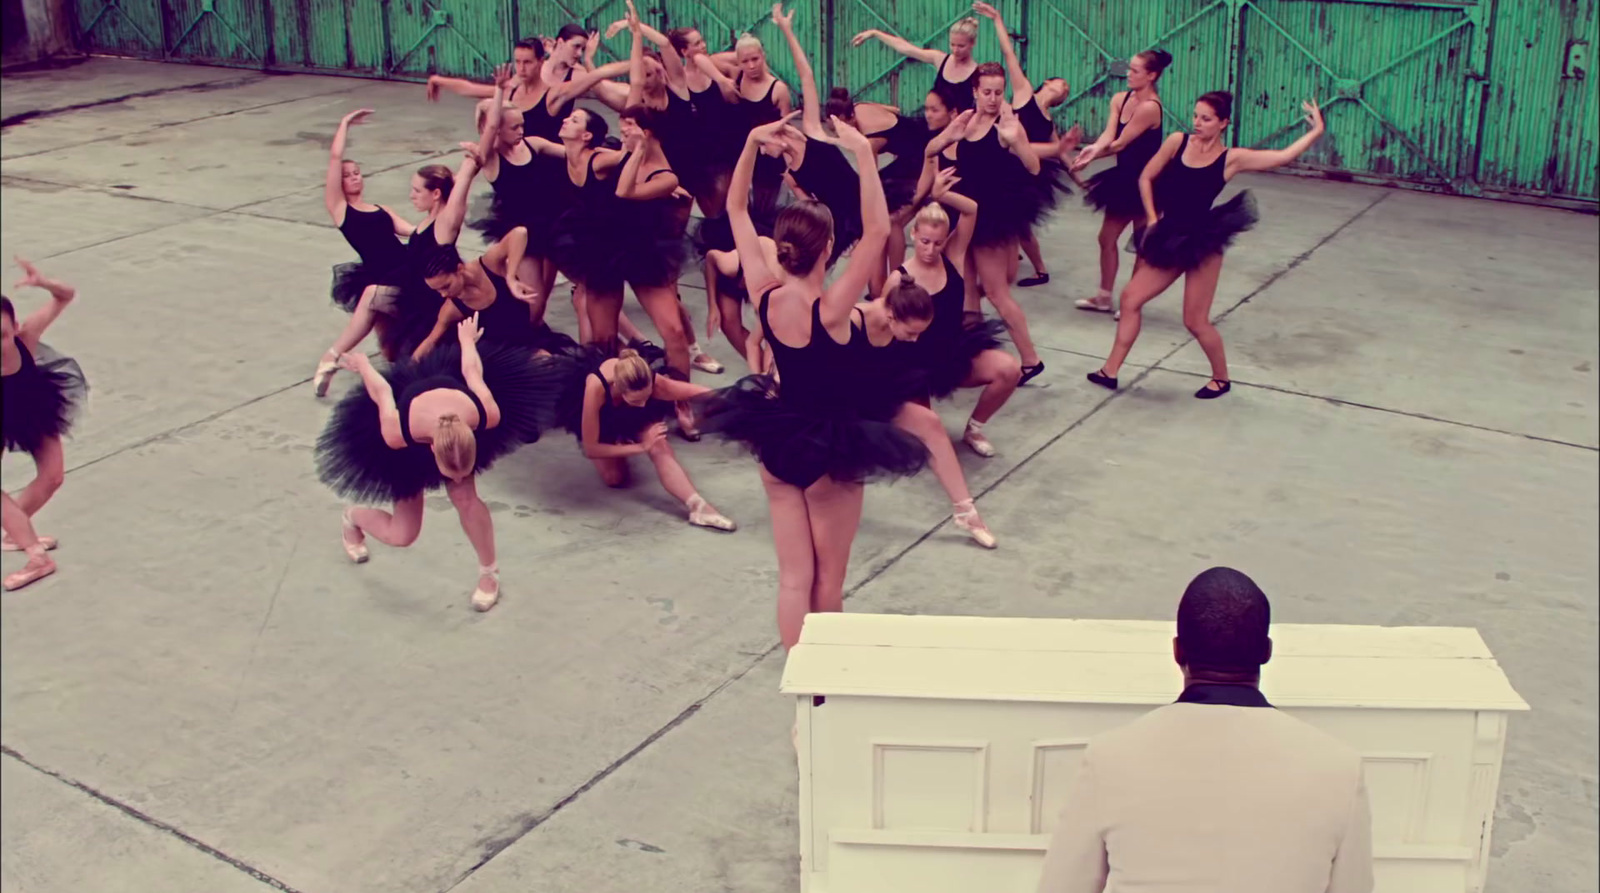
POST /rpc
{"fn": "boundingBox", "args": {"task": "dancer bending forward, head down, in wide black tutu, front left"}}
[317,315,562,611]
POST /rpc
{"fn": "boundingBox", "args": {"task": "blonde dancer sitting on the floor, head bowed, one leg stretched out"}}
[562,347,738,531]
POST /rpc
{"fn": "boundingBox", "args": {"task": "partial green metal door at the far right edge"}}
[1478,0,1597,202]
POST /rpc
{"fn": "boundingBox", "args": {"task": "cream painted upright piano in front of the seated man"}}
[782,615,1528,893]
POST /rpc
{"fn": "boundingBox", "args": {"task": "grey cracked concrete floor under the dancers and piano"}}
[0,61,1600,893]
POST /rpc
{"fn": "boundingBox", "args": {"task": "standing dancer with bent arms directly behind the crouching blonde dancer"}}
[926,62,1050,384]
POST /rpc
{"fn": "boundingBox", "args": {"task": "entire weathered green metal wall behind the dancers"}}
[67,0,1600,208]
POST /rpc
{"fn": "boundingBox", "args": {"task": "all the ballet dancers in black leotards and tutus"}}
[0,2,1323,647]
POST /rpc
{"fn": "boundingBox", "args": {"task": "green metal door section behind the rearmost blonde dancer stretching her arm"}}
[822,0,1026,109]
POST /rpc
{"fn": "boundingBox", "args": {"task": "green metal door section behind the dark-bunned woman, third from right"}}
[1027,0,1235,141]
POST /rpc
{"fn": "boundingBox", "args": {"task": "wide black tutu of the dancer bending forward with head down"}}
[317,344,563,504]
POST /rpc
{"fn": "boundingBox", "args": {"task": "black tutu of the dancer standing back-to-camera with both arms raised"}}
[693,374,928,488]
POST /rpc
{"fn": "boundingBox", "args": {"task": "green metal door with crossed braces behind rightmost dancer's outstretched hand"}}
[1234,0,1485,192]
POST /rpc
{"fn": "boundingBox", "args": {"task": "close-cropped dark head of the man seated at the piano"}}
[1176,568,1272,675]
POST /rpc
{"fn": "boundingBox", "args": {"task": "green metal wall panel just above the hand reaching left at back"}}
[389,0,512,80]
